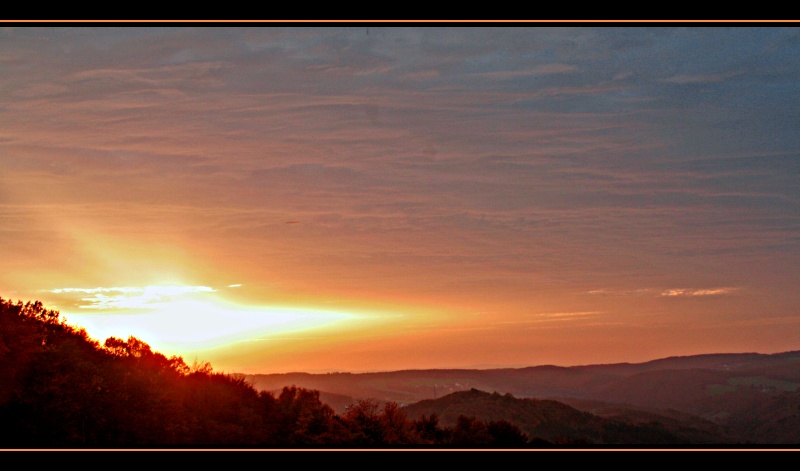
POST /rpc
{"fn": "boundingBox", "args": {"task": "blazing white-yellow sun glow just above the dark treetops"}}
[60,286,360,353]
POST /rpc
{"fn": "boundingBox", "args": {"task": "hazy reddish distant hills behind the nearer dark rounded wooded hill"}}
[247,351,800,443]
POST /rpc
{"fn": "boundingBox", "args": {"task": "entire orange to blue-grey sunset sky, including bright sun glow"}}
[0,24,800,373]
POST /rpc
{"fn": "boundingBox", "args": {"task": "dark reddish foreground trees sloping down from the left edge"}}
[0,298,546,448]
